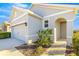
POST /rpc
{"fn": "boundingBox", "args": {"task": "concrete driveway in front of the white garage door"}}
[0,39,24,56]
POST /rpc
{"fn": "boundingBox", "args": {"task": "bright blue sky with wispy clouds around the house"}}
[0,3,79,30]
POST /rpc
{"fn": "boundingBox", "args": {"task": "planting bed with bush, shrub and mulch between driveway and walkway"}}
[16,29,52,56]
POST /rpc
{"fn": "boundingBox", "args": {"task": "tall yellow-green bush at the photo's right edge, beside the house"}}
[73,32,79,55]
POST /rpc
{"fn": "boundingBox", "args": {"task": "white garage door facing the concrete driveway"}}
[13,24,27,41]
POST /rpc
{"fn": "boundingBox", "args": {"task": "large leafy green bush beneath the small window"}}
[37,29,52,47]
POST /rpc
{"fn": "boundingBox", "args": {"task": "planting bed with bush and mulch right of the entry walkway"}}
[66,31,79,56]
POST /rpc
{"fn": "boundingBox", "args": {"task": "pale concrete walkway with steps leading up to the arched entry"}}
[42,41,66,56]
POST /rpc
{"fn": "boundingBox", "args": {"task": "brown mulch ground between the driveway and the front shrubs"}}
[16,44,47,56]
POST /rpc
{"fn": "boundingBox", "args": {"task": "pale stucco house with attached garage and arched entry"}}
[11,4,75,46]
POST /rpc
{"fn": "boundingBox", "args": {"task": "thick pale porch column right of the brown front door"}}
[66,20,73,46]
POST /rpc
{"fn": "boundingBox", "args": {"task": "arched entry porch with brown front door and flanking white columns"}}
[54,18,73,46]
